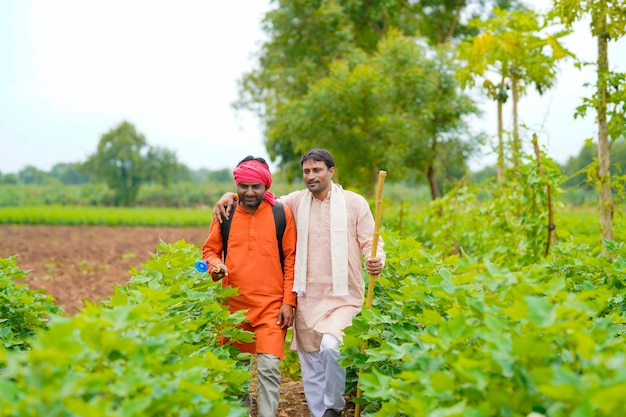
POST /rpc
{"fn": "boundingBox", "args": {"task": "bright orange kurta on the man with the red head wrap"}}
[202,200,296,359]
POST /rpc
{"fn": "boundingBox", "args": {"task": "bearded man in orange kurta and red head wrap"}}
[202,156,296,417]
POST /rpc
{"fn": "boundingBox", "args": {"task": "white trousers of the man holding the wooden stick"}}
[298,333,346,417]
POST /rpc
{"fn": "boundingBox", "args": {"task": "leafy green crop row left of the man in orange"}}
[0,241,251,417]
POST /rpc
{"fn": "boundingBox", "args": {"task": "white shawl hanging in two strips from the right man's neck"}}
[293,183,349,297]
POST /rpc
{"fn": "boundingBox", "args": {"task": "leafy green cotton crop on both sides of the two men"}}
[0,154,626,417]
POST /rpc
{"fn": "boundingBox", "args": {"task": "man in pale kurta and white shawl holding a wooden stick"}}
[281,149,385,417]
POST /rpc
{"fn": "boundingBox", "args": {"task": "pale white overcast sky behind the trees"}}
[0,0,626,173]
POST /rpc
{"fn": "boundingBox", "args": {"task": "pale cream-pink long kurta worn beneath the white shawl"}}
[281,185,385,352]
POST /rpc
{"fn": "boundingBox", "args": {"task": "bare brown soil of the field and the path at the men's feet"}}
[0,225,354,417]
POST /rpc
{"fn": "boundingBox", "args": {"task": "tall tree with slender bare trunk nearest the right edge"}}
[551,0,626,241]
